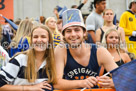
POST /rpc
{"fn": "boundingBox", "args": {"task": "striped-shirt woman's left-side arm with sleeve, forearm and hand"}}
[0,55,51,91]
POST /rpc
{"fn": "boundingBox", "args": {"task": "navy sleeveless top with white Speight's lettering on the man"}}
[64,45,99,80]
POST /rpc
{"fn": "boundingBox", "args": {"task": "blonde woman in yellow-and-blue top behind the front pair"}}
[45,17,61,47]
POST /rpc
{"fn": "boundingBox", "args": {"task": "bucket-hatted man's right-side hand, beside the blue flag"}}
[97,76,114,88]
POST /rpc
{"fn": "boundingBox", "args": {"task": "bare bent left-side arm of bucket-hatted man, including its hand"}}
[54,45,97,89]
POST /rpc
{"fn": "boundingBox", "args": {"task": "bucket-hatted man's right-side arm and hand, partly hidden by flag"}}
[97,48,118,88]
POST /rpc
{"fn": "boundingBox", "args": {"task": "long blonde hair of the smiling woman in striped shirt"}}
[11,25,57,84]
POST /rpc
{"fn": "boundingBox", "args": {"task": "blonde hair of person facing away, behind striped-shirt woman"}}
[13,19,33,46]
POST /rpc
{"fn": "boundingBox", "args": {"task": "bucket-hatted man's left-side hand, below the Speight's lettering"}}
[81,76,98,88]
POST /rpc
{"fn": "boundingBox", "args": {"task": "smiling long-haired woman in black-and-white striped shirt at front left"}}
[0,25,56,91]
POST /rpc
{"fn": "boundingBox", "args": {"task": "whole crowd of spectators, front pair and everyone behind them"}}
[0,0,136,91]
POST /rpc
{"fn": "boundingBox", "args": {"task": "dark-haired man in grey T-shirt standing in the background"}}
[86,0,106,43]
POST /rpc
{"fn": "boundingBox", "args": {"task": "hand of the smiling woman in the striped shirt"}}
[31,81,51,91]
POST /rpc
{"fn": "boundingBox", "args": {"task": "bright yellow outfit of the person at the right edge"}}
[120,10,136,55]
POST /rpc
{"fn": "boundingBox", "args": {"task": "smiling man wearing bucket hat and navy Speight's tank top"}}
[54,9,117,90]
